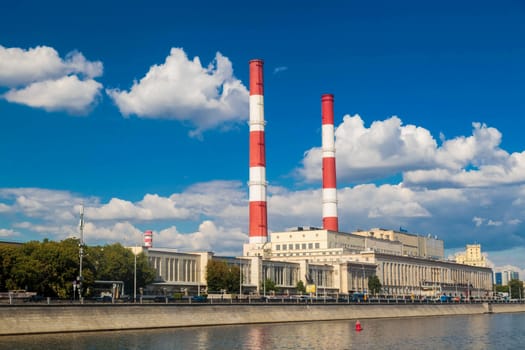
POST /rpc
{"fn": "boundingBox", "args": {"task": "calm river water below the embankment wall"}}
[0,313,525,350]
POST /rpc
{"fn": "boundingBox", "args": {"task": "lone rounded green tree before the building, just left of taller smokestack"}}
[206,260,240,293]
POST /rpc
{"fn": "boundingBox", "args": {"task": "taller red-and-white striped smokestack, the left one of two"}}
[249,60,268,243]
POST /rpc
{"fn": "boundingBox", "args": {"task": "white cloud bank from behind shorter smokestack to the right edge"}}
[298,115,525,188]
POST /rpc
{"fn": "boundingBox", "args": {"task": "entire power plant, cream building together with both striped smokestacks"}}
[133,60,493,297]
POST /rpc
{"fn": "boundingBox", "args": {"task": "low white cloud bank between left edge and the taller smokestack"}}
[0,185,248,255]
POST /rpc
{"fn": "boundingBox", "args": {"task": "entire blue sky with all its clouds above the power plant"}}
[0,0,525,270]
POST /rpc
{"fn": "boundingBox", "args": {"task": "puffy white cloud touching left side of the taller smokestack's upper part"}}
[106,48,249,135]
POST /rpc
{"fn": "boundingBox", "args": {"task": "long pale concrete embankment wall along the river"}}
[0,304,525,335]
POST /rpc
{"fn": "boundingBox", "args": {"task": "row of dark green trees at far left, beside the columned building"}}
[0,238,155,299]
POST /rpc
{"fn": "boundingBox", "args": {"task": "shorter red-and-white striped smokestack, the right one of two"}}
[321,94,339,232]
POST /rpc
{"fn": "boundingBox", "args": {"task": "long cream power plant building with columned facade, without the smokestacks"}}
[134,227,492,298]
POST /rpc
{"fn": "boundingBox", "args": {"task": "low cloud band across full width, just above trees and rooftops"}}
[0,176,525,266]
